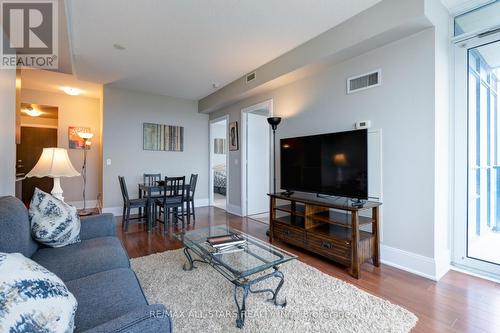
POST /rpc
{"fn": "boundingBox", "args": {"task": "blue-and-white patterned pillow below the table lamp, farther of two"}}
[29,188,80,247]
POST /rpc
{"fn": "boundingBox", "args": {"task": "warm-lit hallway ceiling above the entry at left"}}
[21,69,102,98]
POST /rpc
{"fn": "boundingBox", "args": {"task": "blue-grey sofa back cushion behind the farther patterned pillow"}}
[0,197,38,257]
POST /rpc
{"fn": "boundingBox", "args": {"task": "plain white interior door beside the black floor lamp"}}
[245,113,271,215]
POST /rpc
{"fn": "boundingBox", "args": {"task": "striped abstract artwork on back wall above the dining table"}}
[142,123,184,151]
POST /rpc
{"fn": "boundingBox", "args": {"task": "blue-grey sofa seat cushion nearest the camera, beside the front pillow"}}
[66,268,148,332]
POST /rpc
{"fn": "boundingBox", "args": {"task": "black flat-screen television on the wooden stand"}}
[280,129,368,200]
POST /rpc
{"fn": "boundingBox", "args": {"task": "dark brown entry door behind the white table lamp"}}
[16,127,57,205]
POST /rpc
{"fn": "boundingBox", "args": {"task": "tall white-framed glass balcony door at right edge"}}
[454,34,500,279]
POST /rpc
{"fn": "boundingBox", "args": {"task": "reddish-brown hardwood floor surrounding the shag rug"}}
[117,207,500,333]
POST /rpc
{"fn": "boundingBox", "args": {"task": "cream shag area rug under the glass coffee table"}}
[132,250,418,333]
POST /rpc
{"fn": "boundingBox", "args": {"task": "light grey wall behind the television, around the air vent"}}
[210,28,444,277]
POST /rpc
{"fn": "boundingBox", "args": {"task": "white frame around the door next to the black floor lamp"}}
[241,98,274,216]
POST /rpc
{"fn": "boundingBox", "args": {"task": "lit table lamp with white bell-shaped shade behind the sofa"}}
[26,148,80,201]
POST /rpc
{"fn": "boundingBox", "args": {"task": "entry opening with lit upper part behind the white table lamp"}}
[16,103,58,205]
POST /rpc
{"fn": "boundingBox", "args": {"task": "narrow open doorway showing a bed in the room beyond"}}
[209,116,229,210]
